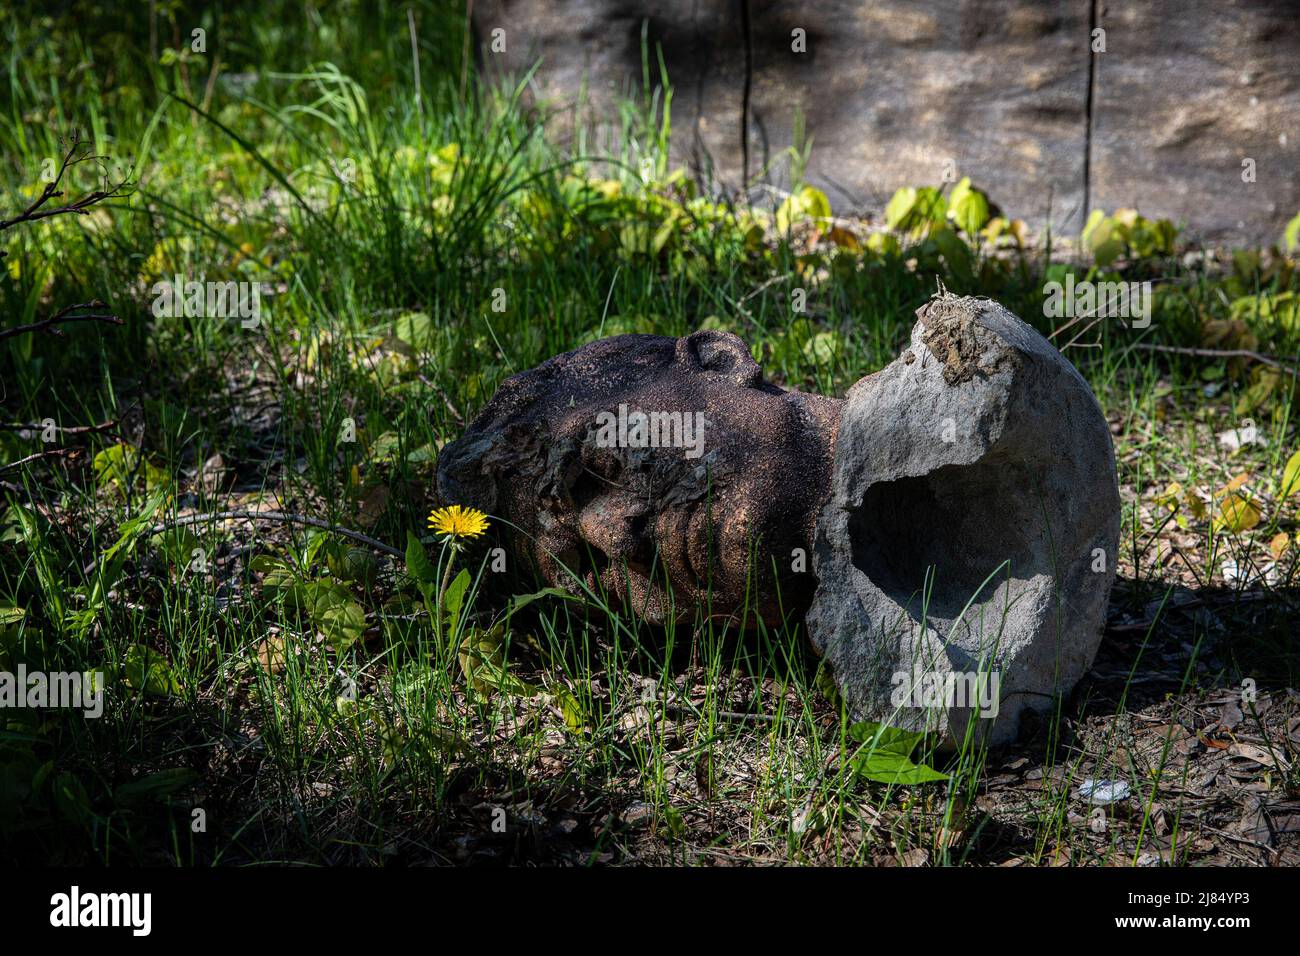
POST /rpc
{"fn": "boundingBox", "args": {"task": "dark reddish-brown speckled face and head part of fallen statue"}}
[438,330,841,623]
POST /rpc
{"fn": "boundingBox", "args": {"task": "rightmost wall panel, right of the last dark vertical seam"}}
[1092,0,1300,242]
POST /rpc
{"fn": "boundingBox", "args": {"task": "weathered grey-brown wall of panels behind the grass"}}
[473,0,1300,242]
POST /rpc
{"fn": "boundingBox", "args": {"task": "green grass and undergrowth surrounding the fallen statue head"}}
[0,4,1300,865]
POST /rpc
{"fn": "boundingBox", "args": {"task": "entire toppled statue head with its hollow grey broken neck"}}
[438,295,1119,743]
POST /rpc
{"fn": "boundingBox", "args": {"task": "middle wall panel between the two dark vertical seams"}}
[751,0,1088,230]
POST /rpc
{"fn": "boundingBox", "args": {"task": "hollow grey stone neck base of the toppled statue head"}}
[807,295,1119,744]
